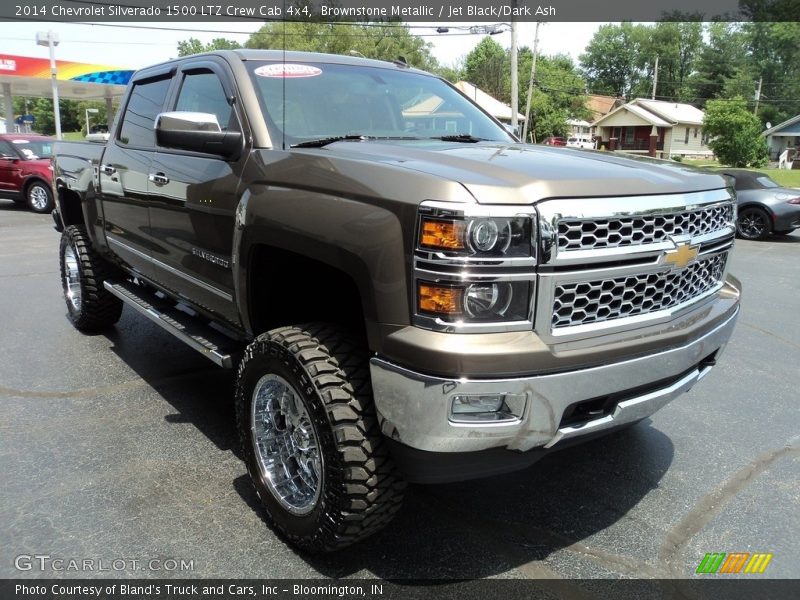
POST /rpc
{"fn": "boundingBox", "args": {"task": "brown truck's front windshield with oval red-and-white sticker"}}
[247,61,512,147]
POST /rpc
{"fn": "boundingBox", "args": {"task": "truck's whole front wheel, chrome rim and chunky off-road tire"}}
[236,324,405,551]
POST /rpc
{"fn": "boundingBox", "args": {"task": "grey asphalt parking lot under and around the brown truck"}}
[0,200,800,579]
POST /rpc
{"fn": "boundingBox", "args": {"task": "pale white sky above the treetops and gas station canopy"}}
[0,22,601,69]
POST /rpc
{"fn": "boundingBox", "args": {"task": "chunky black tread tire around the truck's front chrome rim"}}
[236,323,406,552]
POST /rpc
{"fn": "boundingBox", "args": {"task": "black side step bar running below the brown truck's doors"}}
[104,281,240,369]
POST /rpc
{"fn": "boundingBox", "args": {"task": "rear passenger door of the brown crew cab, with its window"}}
[98,70,172,278]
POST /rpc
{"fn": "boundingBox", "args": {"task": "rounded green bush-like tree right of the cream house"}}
[703,98,768,167]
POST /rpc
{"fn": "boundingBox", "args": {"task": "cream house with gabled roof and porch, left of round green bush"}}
[594,98,713,158]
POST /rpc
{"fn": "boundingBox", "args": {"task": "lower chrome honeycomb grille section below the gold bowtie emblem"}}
[552,252,728,329]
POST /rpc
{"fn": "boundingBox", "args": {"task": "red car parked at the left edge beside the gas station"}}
[0,133,54,213]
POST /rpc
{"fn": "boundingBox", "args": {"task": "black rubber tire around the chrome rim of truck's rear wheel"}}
[60,225,122,331]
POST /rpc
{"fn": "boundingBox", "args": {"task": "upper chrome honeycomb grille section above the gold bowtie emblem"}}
[558,202,733,251]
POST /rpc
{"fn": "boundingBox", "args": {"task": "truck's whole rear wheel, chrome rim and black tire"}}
[59,225,122,331]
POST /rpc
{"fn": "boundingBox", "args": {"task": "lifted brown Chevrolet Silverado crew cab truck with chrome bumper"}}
[53,50,740,550]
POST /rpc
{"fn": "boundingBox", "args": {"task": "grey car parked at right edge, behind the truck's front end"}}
[722,169,800,240]
